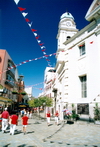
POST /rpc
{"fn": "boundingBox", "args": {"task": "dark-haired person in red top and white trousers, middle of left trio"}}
[9,112,18,135]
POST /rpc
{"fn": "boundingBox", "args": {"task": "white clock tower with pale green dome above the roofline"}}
[57,12,78,51]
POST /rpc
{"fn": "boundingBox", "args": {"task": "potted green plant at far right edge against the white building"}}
[94,103,100,124]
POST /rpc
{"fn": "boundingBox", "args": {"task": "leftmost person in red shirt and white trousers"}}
[1,108,9,133]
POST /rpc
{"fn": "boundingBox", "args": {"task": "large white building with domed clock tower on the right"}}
[52,0,100,120]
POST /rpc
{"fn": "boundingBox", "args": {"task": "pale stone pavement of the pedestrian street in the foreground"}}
[0,115,100,147]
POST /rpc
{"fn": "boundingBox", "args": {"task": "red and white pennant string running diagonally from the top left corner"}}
[14,0,51,67]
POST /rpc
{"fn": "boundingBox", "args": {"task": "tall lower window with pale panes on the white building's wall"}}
[80,76,87,98]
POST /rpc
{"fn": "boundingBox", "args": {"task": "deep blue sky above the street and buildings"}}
[0,0,92,97]
